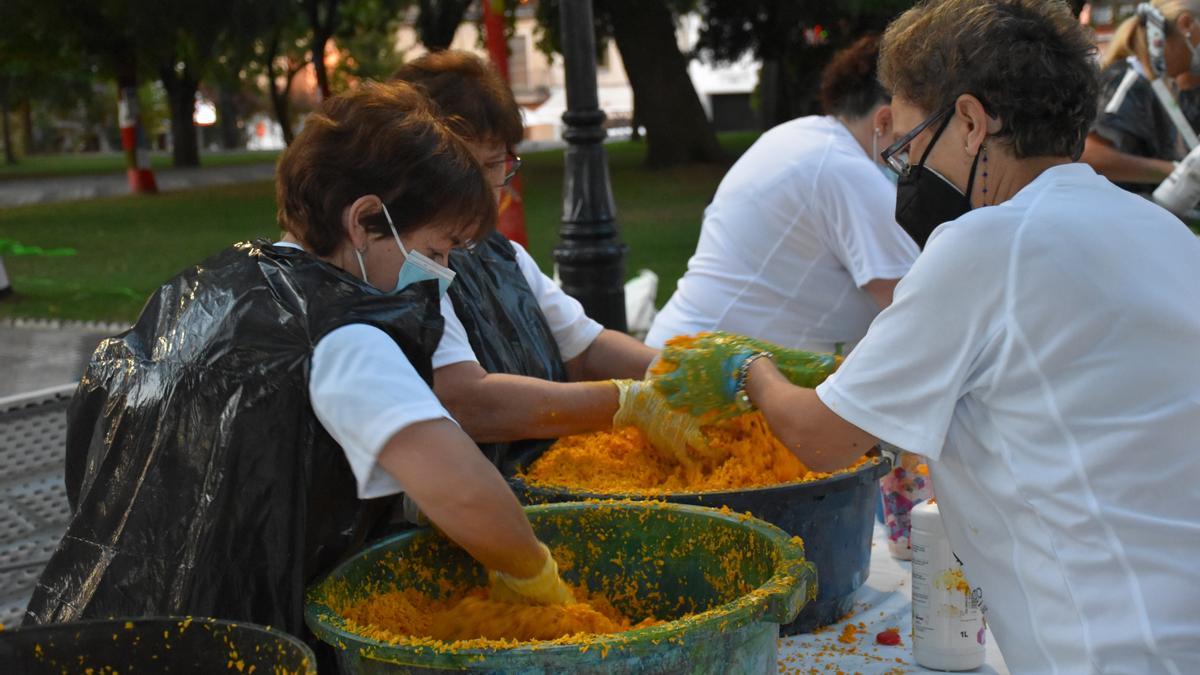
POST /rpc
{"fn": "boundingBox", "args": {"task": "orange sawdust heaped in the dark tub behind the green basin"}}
[522,412,868,494]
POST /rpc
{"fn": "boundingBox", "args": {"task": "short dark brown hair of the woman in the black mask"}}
[880,0,1099,159]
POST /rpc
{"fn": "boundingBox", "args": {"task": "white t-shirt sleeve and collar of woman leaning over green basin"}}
[276,241,454,500]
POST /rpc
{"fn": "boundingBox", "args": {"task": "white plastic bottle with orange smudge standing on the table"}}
[912,502,986,670]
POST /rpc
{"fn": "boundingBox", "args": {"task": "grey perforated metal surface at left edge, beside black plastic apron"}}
[0,384,74,626]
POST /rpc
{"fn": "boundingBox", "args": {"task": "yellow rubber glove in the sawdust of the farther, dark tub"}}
[612,380,720,466]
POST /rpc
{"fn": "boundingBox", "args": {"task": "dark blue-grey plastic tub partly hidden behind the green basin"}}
[509,456,892,635]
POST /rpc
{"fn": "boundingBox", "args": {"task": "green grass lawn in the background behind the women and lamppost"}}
[0,133,756,321]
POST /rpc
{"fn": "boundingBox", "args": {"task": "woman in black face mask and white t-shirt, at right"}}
[659,0,1200,673]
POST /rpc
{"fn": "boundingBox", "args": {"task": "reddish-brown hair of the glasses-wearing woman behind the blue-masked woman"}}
[392,49,524,148]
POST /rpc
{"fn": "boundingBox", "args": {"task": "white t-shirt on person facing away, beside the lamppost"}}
[646,117,918,352]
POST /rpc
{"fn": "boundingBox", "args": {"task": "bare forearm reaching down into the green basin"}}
[379,419,544,578]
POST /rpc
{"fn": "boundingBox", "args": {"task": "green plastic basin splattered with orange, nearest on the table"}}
[305,501,816,674]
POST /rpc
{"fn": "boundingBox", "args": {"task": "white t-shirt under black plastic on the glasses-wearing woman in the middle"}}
[433,241,604,370]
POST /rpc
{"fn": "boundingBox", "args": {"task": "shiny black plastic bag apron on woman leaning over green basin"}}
[26,243,442,635]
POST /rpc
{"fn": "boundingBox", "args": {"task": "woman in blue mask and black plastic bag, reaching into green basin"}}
[28,84,569,634]
